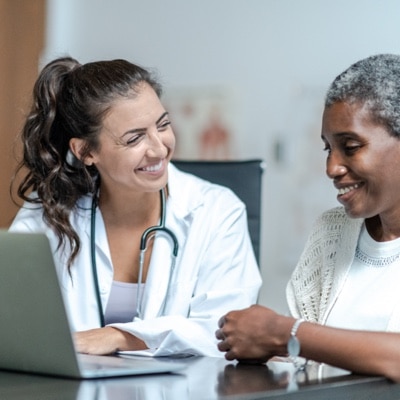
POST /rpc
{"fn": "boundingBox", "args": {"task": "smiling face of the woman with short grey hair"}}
[321,102,400,220]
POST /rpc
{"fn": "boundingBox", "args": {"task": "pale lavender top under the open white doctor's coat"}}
[104,281,144,325]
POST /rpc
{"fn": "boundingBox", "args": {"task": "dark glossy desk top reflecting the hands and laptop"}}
[0,357,400,400]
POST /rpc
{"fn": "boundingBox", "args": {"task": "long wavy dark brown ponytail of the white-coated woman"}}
[12,57,90,265]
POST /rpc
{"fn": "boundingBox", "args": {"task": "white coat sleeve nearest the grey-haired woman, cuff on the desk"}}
[102,193,261,357]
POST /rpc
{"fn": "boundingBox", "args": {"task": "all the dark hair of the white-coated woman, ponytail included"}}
[11,57,162,268]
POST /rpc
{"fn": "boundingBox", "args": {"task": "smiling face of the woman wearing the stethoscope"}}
[85,83,175,197]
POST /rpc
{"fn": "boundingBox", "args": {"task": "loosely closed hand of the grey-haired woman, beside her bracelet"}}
[215,305,294,363]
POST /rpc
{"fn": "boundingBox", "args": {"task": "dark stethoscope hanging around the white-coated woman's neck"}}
[90,189,179,327]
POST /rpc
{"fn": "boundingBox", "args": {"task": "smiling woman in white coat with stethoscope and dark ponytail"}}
[10,57,261,356]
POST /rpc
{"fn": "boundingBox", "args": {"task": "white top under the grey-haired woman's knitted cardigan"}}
[326,225,400,331]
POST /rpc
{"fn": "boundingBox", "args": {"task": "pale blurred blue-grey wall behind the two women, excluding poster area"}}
[43,0,400,311]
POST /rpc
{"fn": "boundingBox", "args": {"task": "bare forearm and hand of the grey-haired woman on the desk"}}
[216,305,400,382]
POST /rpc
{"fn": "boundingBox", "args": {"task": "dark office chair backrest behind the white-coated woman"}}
[172,159,264,265]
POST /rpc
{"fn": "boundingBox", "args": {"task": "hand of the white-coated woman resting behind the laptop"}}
[74,326,147,355]
